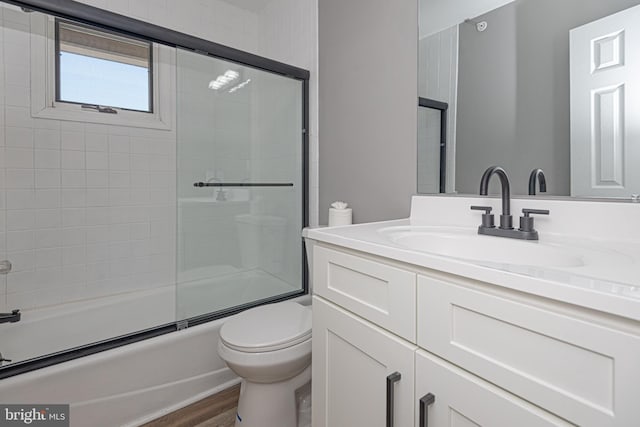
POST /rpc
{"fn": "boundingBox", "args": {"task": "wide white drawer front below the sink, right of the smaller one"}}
[417,276,640,427]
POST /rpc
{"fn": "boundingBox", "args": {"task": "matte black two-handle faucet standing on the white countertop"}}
[471,166,549,240]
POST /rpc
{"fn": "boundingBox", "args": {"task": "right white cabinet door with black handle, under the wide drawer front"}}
[416,350,573,427]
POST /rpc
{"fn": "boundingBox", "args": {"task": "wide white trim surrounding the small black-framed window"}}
[30,13,176,131]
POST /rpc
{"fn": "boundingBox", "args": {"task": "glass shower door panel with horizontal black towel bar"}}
[177,49,304,319]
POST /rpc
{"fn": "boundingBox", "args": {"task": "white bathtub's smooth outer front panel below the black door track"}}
[0,314,238,427]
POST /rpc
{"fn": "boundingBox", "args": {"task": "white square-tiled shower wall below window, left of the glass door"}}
[2,3,176,309]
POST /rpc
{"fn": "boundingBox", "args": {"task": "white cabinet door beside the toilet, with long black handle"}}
[312,296,416,427]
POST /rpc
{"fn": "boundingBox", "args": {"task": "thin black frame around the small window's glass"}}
[53,17,155,114]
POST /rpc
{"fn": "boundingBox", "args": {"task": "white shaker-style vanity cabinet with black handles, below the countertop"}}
[313,243,640,427]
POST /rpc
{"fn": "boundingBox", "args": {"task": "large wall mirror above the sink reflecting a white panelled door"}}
[417,0,640,200]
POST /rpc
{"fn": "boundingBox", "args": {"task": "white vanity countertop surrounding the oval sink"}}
[304,197,640,320]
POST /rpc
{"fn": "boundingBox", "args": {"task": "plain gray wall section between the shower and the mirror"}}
[318,0,418,224]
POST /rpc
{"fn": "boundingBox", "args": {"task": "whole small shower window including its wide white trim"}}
[29,12,176,130]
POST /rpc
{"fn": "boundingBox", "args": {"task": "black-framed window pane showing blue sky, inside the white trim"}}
[55,19,153,113]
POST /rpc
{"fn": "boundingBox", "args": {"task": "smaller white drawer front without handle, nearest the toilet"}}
[313,245,416,343]
